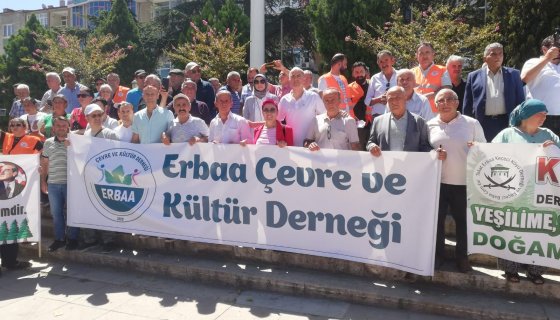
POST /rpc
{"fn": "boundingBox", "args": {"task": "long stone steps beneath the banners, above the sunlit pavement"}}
[17,239,560,320]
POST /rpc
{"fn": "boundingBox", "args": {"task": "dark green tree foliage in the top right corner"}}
[489,0,560,68]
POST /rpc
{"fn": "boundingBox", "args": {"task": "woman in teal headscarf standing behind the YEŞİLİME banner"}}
[492,99,560,284]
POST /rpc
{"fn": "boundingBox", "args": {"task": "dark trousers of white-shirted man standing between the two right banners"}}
[436,183,467,259]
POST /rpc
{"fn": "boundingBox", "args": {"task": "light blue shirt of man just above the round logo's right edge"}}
[132,107,173,143]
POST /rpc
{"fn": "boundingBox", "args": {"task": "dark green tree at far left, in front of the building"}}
[4,14,50,97]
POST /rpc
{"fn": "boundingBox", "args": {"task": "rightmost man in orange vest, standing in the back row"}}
[411,42,451,113]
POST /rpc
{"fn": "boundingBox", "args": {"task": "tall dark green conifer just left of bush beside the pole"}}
[95,0,153,83]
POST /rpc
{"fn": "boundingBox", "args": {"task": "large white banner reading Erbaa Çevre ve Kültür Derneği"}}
[68,135,440,275]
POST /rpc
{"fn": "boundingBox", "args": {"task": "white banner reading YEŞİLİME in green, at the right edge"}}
[467,144,560,269]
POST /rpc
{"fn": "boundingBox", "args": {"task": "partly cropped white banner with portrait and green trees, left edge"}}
[0,154,41,244]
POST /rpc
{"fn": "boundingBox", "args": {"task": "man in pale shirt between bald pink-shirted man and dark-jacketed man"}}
[304,88,360,151]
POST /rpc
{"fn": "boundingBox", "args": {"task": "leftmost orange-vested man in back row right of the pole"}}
[319,53,353,113]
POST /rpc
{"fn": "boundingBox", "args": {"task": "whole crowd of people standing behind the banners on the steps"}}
[0,37,560,284]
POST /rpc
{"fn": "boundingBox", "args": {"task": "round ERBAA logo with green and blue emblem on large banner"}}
[84,148,156,222]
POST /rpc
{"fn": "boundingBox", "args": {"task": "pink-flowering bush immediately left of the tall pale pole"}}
[166,22,247,81]
